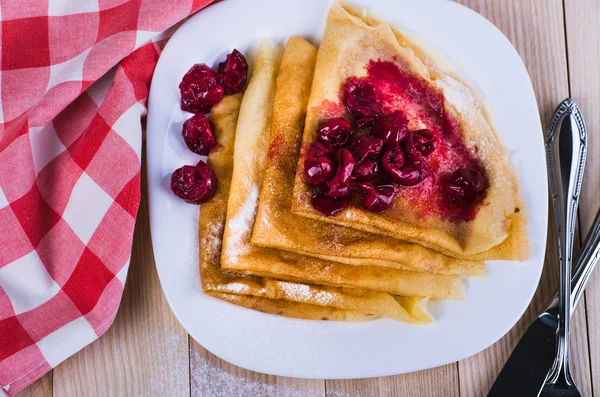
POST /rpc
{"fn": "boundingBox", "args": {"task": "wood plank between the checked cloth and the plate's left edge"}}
[54,155,190,397]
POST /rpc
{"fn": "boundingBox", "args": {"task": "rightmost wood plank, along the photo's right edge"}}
[564,0,600,396]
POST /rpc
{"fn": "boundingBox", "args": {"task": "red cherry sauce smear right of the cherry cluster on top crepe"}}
[366,61,487,221]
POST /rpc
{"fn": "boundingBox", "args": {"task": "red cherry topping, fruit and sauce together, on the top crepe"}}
[307,61,488,221]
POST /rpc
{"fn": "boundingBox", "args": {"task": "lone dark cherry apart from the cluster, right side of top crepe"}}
[444,169,486,208]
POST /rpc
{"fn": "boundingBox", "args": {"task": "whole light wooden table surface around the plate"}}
[21,0,600,397]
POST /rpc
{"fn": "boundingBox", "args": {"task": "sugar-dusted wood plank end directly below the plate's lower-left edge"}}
[190,337,325,397]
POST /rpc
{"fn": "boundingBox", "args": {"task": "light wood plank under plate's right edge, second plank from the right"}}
[452,0,591,396]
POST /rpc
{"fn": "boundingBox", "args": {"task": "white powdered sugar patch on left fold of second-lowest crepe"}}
[225,185,258,264]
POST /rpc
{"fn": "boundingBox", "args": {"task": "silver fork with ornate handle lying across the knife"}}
[540,98,587,397]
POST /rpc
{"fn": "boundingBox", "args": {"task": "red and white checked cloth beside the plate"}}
[0,0,210,396]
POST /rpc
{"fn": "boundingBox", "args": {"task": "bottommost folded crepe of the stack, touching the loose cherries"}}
[198,53,432,324]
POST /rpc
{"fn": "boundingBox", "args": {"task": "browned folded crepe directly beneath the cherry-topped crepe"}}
[251,38,485,276]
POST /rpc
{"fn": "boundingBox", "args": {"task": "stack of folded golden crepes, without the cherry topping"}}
[199,3,529,324]
